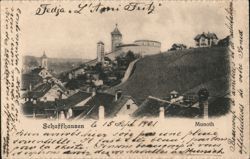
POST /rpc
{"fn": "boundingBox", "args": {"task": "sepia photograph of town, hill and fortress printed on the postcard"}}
[22,3,231,120]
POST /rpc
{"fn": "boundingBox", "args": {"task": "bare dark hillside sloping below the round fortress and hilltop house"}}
[109,47,230,103]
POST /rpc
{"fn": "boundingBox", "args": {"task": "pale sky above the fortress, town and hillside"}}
[20,1,228,59]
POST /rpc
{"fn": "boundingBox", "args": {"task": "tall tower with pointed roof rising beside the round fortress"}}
[111,24,122,52]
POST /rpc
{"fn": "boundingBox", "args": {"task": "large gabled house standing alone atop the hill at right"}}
[194,32,218,47]
